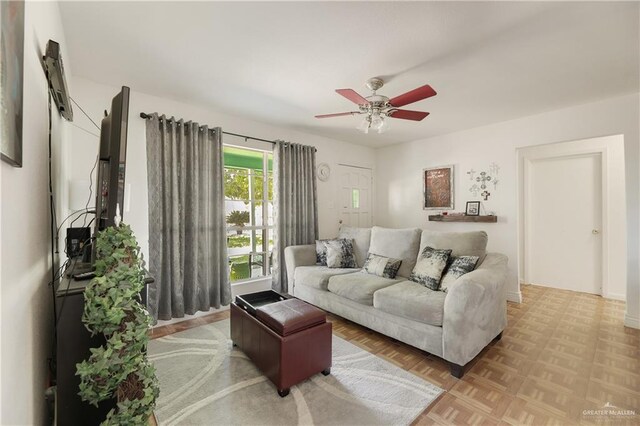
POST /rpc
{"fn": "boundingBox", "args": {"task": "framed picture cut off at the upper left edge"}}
[0,1,24,167]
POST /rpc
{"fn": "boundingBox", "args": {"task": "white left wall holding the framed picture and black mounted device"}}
[0,2,71,425]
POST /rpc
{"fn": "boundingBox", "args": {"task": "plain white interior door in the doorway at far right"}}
[525,153,602,294]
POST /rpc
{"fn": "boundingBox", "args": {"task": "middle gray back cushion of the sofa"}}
[369,226,420,278]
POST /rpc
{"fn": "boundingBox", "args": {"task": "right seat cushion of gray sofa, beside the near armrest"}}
[373,281,447,327]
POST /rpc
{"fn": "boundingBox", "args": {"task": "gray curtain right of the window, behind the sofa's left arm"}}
[272,141,318,293]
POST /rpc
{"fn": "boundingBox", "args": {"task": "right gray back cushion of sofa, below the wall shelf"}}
[419,229,488,259]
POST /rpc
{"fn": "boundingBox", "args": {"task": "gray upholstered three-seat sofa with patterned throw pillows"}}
[285,226,507,377]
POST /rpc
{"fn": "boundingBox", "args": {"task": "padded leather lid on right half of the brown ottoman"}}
[256,299,326,336]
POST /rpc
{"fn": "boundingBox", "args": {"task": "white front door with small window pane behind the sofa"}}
[339,165,372,228]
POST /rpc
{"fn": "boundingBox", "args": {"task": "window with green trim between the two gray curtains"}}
[224,146,273,283]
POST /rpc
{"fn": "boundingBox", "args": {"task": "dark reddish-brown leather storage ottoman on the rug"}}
[231,299,331,397]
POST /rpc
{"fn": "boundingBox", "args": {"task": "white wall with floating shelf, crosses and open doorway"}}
[376,94,640,324]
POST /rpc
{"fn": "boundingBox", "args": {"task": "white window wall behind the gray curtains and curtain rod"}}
[68,77,375,278]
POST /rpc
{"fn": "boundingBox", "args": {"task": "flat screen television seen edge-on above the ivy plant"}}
[96,86,129,232]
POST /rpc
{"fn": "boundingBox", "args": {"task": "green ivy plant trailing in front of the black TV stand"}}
[76,224,160,425]
